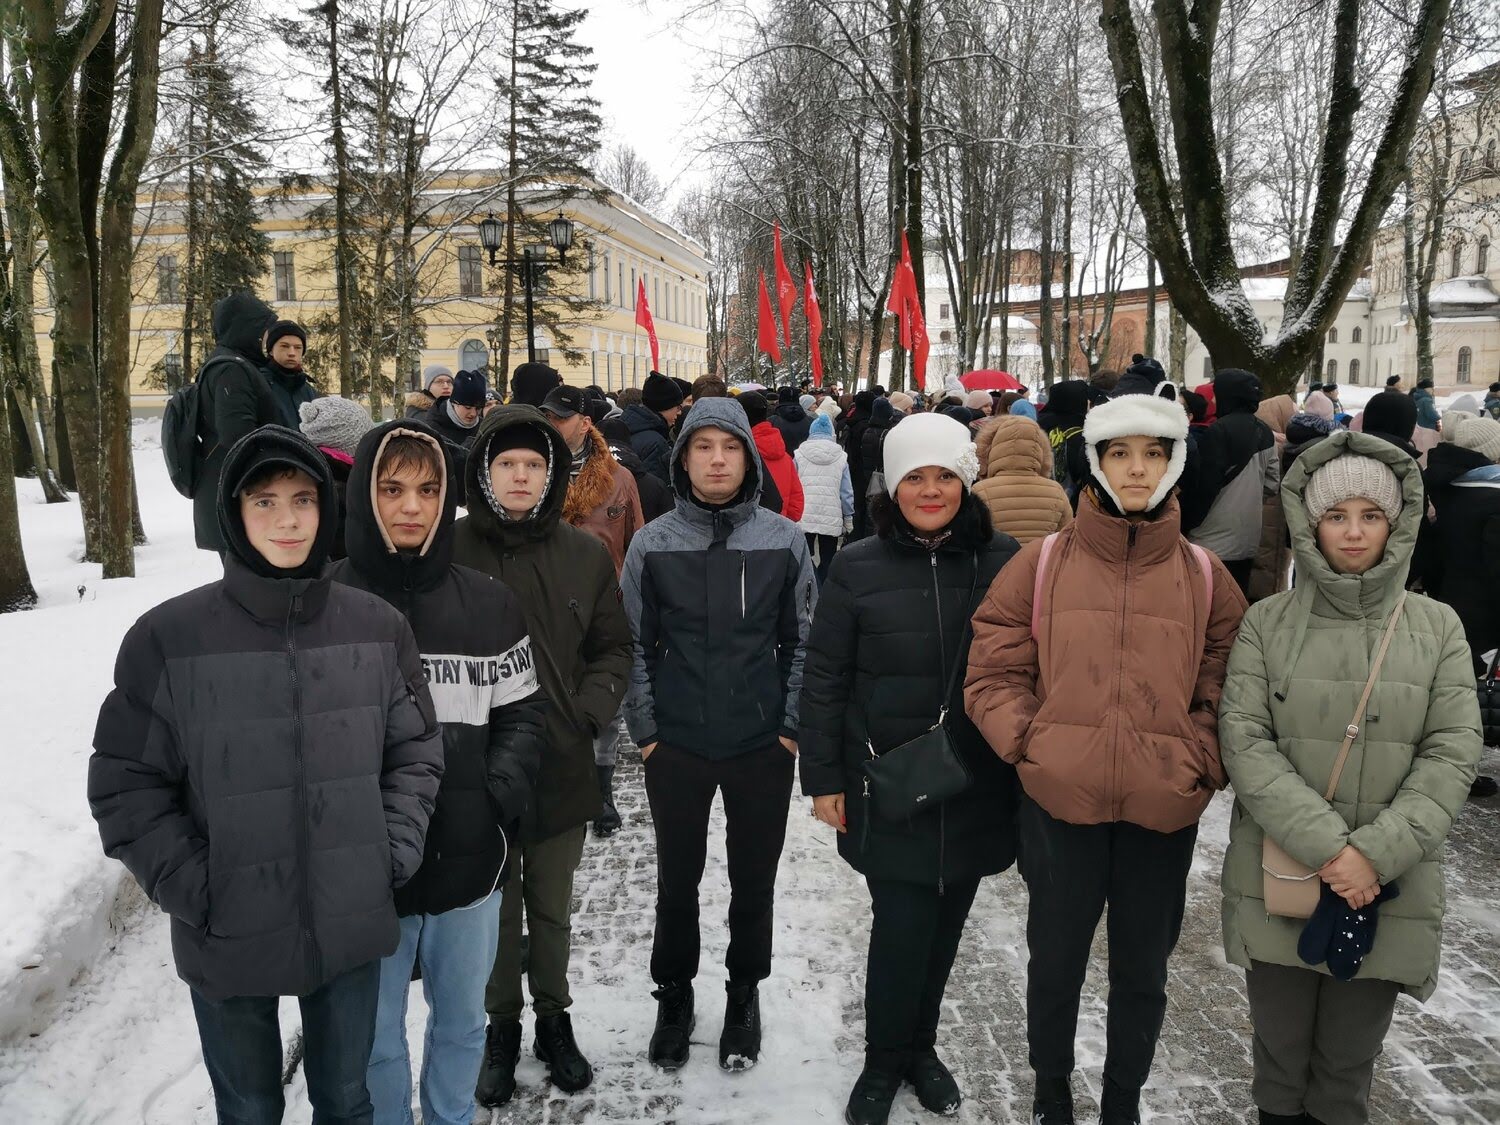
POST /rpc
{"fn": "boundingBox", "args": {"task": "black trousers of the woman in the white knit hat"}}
[864,879,980,1062]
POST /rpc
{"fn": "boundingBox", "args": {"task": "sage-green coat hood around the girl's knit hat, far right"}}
[1281,431,1425,618]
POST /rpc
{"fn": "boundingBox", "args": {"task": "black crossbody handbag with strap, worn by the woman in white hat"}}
[864,554,980,821]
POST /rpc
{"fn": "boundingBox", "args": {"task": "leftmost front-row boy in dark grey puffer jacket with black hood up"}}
[89,426,443,1122]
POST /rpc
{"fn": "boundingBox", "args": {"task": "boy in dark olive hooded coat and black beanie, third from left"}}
[453,405,630,1106]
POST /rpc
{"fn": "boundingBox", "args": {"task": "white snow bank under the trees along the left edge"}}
[0,444,221,1040]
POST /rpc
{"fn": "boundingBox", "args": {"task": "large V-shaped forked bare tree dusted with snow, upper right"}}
[1100,0,1452,392]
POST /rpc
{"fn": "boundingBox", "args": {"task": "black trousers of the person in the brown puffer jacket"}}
[1020,798,1199,1112]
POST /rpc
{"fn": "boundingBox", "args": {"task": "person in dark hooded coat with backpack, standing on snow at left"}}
[192,293,282,555]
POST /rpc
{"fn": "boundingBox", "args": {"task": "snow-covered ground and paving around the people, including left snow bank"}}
[0,420,1500,1125]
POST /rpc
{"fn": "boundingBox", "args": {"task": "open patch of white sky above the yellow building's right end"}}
[578,0,723,204]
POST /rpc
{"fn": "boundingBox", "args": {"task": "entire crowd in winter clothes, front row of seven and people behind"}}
[89,292,1500,1125]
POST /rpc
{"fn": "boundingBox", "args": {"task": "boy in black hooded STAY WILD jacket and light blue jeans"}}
[330,420,548,1125]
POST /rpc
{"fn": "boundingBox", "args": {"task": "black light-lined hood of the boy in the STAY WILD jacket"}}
[344,420,459,593]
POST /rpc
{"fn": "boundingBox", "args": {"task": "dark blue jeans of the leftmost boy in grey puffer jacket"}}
[192,962,380,1125]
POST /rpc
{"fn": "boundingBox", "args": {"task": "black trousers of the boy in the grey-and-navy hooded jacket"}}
[645,743,795,984]
